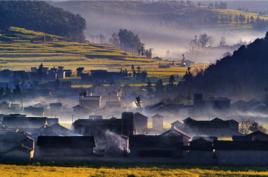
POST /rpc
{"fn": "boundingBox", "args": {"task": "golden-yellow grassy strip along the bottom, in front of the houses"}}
[0,165,268,177]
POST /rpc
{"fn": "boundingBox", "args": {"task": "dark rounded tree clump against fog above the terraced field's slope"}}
[110,29,152,58]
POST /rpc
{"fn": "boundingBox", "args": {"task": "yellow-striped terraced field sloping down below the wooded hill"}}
[0,27,208,77]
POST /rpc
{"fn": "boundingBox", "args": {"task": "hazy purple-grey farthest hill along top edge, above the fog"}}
[55,0,268,26]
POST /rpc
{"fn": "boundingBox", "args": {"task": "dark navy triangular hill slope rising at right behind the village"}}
[179,33,268,98]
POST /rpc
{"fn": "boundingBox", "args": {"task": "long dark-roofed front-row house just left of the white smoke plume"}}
[34,136,95,161]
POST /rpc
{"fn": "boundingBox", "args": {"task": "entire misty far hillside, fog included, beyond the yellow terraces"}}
[52,0,267,62]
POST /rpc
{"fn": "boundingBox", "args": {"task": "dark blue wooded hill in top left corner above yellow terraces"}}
[0,1,86,40]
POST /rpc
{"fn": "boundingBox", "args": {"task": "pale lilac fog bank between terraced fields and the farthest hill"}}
[56,1,265,63]
